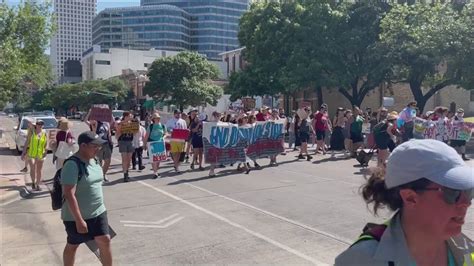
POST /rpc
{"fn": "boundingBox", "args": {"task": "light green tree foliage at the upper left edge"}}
[0,1,54,105]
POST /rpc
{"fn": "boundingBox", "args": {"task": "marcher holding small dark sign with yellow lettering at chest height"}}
[115,112,135,182]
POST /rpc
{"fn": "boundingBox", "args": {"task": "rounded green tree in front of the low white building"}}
[144,52,223,108]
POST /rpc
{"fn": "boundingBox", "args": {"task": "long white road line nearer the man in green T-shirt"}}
[138,181,328,265]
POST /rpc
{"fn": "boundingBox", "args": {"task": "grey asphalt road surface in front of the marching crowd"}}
[0,119,474,265]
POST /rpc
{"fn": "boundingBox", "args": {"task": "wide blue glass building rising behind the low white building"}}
[92,0,249,60]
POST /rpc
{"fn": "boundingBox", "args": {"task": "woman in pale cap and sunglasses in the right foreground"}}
[335,139,474,266]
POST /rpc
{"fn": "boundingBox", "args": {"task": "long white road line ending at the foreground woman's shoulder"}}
[173,178,351,245]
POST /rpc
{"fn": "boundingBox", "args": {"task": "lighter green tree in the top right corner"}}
[381,3,474,111]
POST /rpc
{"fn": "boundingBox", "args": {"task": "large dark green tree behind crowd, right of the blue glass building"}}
[235,0,389,105]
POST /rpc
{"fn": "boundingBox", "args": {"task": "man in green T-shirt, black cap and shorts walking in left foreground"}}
[60,131,112,265]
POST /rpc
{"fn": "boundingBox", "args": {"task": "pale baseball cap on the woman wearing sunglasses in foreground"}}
[385,139,474,190]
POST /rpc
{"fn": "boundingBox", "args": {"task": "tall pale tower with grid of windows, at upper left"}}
[50,0,97,83]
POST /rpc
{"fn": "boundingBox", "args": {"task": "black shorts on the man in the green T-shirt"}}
[63,211,109,245]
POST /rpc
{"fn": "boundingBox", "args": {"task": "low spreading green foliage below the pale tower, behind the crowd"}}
[40,78,130,113]
